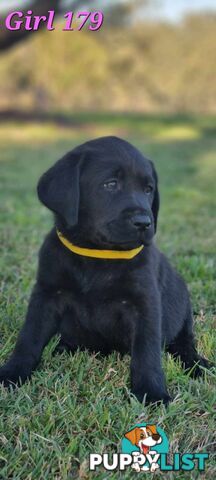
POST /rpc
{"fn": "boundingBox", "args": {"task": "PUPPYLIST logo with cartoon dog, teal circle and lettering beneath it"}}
[89,423,209,473]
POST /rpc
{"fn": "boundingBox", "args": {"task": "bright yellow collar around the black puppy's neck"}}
[57,230,144,260]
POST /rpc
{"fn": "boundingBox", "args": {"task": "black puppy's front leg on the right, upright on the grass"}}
[131,301,170,404]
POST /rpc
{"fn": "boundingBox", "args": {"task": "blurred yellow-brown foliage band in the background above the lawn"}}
[0,14,216,113]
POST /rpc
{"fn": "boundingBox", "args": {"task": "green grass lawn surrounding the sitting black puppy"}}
[0,114,216,480]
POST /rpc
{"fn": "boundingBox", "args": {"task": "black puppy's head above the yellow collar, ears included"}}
[38,137,159,250]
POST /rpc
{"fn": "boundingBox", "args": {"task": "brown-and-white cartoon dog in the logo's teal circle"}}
[125,424,162,472]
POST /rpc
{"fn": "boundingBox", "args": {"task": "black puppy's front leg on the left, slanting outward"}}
[0,286,59,386]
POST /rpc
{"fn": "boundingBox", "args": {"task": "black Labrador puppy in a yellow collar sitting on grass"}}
[0,137,208,403]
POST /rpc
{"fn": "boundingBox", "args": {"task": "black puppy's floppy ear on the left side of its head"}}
[37,152,81,227]
